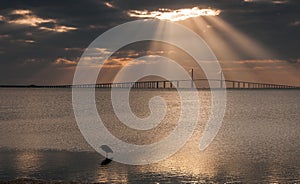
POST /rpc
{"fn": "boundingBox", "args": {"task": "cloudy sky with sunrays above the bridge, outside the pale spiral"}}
[0,0,300,86]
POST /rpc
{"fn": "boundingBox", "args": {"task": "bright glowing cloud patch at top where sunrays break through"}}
[128,7,221,21]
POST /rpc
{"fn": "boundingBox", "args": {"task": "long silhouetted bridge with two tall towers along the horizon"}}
[0,79,300,89]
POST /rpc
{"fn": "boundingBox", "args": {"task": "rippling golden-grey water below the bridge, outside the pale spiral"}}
[0,89,300,183]
